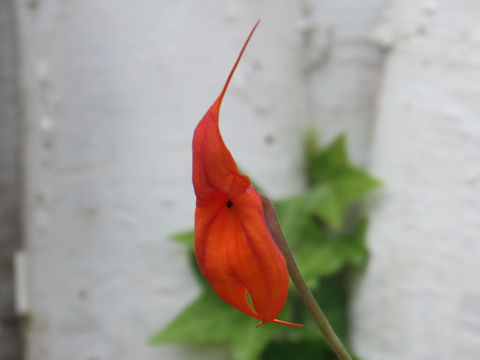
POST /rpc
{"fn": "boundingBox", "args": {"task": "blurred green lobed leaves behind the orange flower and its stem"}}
[150,136,379,360]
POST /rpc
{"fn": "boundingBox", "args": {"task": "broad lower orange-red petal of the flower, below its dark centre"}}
[195,187,289,323]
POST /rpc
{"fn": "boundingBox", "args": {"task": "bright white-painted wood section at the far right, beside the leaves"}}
[352,0,480,360]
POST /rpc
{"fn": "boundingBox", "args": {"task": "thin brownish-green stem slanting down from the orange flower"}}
[261,194,352,360]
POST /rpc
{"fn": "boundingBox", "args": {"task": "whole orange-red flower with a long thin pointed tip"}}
[193,22,302,326]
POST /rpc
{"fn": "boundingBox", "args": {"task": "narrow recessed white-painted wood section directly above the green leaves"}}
[302,0,387,166]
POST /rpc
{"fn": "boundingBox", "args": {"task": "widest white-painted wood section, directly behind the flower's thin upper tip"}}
[17,0,306,360]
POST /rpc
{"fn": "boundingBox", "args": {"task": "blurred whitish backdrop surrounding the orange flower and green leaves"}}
[0,0,480,360]
